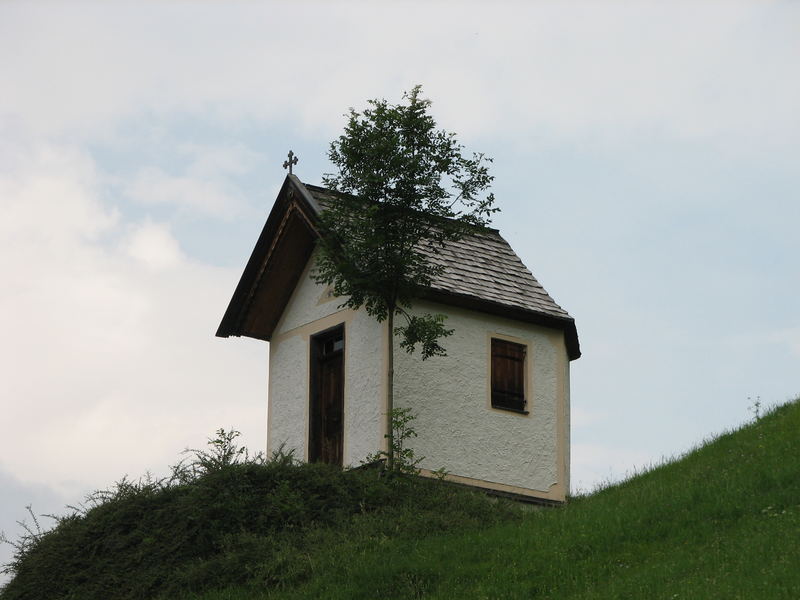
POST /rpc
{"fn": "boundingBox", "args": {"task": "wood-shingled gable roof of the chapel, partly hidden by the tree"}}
[217,175,581,360]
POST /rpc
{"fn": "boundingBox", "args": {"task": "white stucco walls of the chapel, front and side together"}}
[267,251,569,499]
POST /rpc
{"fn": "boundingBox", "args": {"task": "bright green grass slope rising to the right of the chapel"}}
[201,401,800,600]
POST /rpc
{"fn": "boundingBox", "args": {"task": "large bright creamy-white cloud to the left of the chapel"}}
[0,145,267,494]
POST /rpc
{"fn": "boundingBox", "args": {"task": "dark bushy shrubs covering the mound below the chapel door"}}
[0,431,517,600]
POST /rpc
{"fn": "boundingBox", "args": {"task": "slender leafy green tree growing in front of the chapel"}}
[314,86,498,470]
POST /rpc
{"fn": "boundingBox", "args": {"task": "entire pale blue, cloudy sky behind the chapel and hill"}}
[0,0,800,580]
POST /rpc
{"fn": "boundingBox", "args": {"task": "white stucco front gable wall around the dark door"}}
[267,251,385,466]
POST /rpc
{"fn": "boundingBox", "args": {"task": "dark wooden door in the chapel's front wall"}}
[308,326,344,466]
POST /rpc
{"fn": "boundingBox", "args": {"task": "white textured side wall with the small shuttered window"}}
[395,302,568,492]
